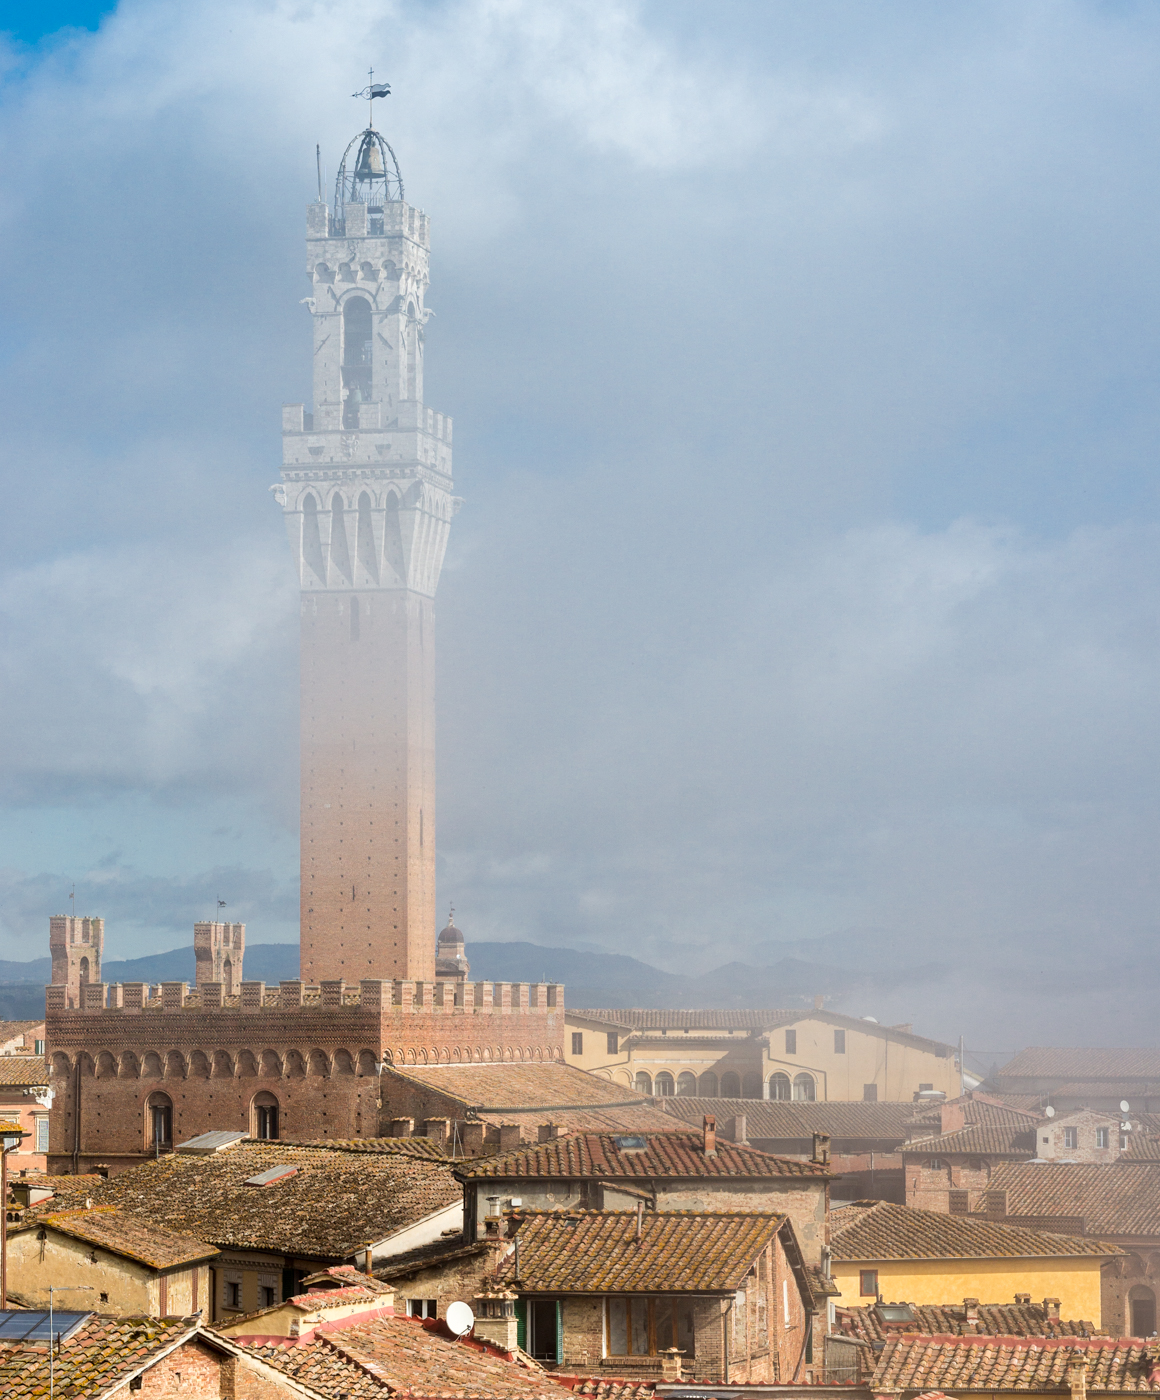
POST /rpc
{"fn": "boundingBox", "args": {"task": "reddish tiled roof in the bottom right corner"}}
[872,1336,1160,1394]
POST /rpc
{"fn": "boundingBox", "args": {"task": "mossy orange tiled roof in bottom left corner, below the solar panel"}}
[0,1313,197,1400]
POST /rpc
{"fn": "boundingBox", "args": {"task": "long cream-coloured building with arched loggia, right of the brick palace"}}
[564,1007,957,1102]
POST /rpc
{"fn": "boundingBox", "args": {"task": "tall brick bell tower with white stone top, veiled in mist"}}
[271,112,459,983]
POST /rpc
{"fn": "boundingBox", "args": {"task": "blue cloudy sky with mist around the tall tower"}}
[0,0,1160,1049]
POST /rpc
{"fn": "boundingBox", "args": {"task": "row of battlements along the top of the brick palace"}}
[45,980,564,1016]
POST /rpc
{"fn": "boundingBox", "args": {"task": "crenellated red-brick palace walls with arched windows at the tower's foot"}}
[46,981,564,1173]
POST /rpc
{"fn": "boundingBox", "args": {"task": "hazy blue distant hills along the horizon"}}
[0,942,865,1021]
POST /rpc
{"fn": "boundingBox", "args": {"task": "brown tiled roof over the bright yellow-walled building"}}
[830,1198,1119,1261]
